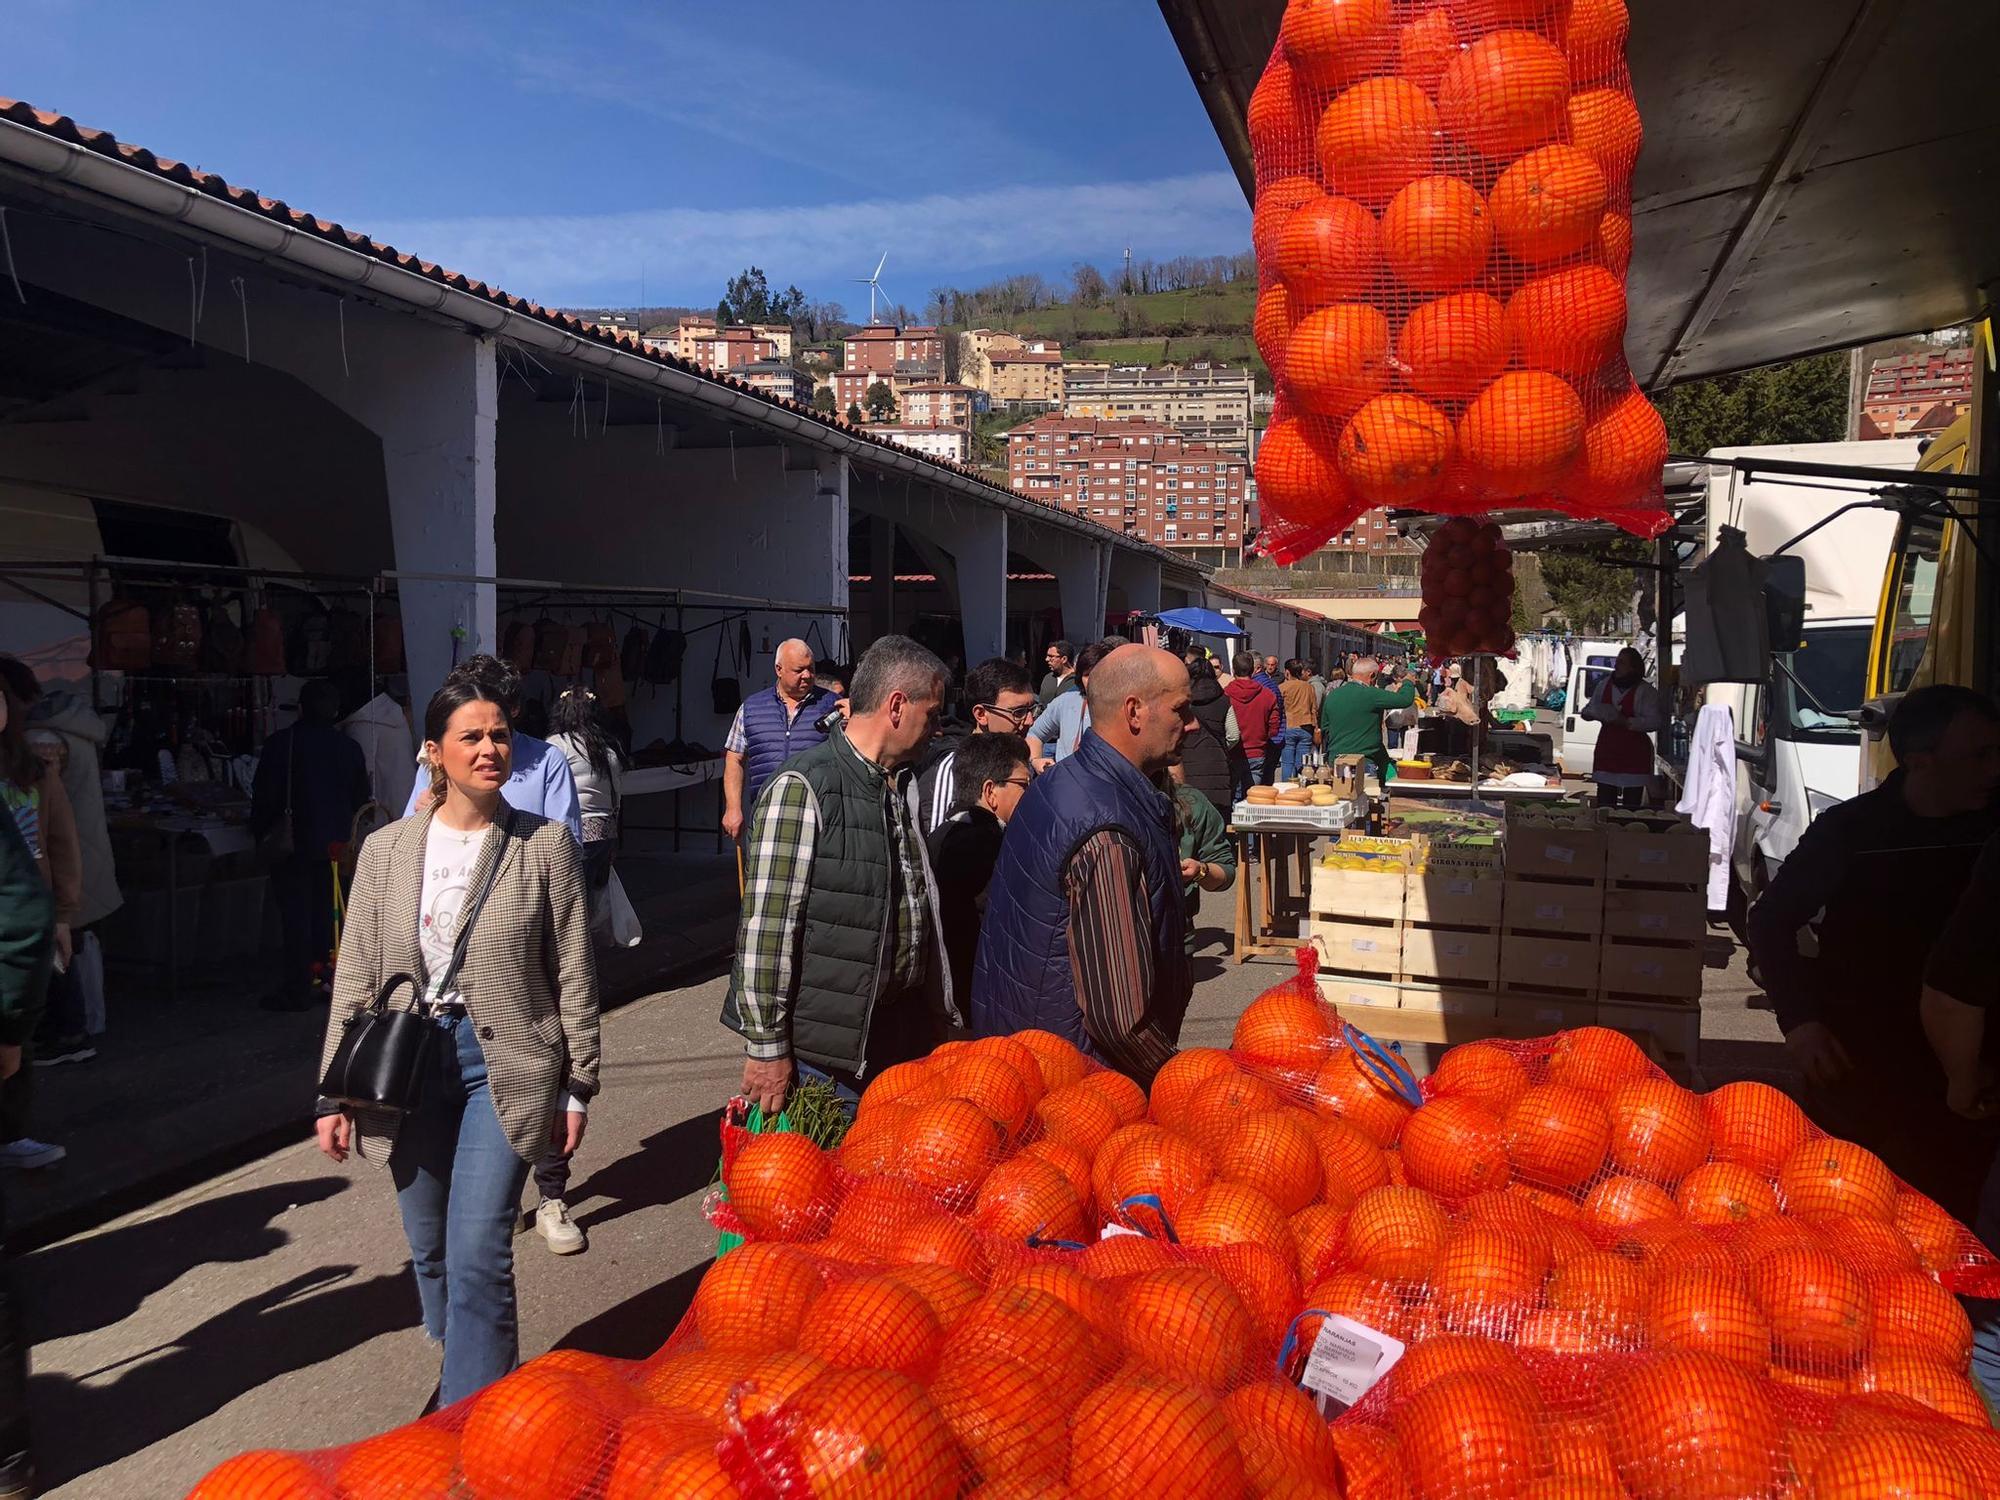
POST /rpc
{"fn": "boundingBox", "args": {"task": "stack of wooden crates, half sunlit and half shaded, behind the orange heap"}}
[1308,814,1708,1066]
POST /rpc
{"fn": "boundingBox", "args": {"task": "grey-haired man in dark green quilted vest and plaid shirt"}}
[722,636,958,1114]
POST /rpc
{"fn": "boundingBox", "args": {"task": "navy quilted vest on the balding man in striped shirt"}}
[972,732,1188,1056]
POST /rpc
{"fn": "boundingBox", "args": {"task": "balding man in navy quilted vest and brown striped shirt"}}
[972,646,1196,1084]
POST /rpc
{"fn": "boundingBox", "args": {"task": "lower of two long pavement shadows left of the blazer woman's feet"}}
[28,1266,416,1488]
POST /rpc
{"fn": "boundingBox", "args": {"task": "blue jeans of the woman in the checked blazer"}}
[388,1016,528,1406]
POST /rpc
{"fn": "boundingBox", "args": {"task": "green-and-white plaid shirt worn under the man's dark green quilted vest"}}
[736,736,930,1062]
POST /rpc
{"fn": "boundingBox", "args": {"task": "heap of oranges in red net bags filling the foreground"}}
[196,952,2000,1500]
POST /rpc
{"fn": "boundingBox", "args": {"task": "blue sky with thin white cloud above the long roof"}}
[0,0,1250,316]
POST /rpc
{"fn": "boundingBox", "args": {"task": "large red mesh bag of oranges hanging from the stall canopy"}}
[1248,0,1668,562]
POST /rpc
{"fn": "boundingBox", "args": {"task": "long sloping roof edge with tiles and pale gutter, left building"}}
[0,98,1214,580]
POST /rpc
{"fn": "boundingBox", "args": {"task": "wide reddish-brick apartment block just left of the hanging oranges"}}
[1006,414,1250,548]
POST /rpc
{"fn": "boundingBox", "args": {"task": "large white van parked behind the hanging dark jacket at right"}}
[1706,438,1918,900]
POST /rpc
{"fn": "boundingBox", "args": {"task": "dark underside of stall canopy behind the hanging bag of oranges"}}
[1160,0,2000,390]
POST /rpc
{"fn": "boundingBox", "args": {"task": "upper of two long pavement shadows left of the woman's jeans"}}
[27,1176,352,1344]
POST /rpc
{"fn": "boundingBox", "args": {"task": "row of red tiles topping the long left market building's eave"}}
[0,96,1032,488]
